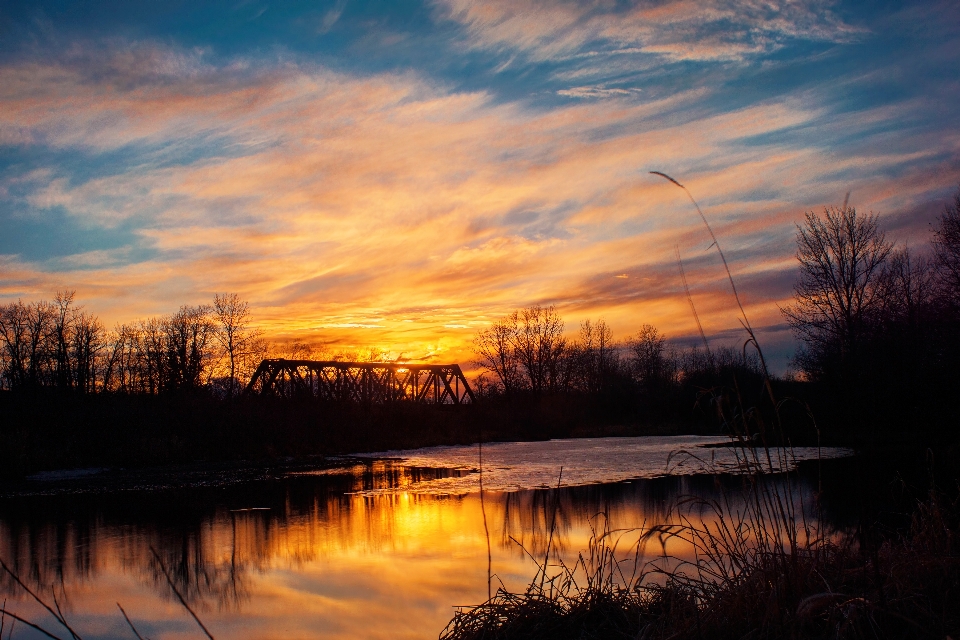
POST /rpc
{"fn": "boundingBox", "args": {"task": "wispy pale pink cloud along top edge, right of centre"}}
[437,0,860,60]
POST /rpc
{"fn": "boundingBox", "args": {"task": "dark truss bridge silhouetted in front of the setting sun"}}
[244,358,474,404]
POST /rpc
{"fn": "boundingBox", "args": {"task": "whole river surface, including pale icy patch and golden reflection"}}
[0,437,849,640]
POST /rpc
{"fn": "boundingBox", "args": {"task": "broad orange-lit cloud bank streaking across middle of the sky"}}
[0,38,957,370]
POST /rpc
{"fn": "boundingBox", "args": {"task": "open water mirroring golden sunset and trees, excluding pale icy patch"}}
[0,461,840,638]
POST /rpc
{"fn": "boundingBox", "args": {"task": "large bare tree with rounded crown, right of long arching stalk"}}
[781,207,892,360]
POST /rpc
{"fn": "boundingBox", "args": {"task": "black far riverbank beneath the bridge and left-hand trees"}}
[0,392,715,480]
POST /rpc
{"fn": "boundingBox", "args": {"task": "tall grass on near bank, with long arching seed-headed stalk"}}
[440,172,960,640]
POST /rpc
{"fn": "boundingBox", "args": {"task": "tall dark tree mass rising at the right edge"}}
[781,186,960,437]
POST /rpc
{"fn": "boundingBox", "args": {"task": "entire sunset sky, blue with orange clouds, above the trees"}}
[0,0,960,371]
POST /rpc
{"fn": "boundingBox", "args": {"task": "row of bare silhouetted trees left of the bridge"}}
[0,292,270,396]
